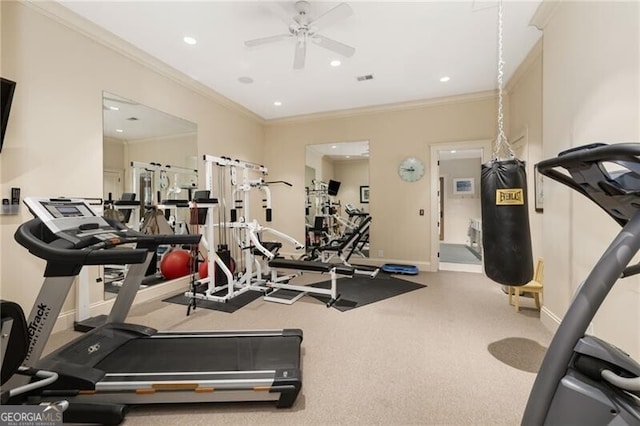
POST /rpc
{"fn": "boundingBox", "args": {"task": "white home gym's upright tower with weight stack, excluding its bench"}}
[185,155,303,302]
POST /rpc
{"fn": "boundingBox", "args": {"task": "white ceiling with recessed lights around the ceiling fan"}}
[60,0,541,119]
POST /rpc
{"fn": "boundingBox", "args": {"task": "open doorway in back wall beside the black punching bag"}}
[431,141,490,273]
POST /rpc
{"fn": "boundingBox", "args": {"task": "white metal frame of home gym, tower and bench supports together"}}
[185,155,351,304]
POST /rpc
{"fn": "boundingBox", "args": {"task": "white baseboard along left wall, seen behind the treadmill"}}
[53,277,189,333]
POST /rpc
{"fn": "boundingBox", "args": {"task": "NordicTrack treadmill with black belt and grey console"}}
[15,198,302,423]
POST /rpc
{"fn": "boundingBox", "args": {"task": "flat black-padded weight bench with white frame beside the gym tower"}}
[264,257,355,308]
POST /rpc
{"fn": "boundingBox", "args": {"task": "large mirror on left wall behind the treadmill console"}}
[102,92,198,299]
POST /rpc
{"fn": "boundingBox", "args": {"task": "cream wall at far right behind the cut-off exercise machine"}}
[542,2,640,358]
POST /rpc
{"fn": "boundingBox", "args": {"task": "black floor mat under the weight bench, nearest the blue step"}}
[309,274,426,312]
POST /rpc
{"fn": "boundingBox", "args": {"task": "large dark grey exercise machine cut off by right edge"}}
[522,143,640,426]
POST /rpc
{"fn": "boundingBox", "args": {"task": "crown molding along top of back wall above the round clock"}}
[264,90,497,127]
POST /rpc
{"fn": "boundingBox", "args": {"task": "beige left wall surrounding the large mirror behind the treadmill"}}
[0,1,262,322]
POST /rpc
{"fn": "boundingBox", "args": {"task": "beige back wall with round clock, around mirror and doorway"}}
[265,94,496,269]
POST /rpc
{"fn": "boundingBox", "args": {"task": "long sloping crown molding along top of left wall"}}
[22,0,264,124]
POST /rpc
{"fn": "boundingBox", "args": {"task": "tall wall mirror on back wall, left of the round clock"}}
[305,141,375,258]
